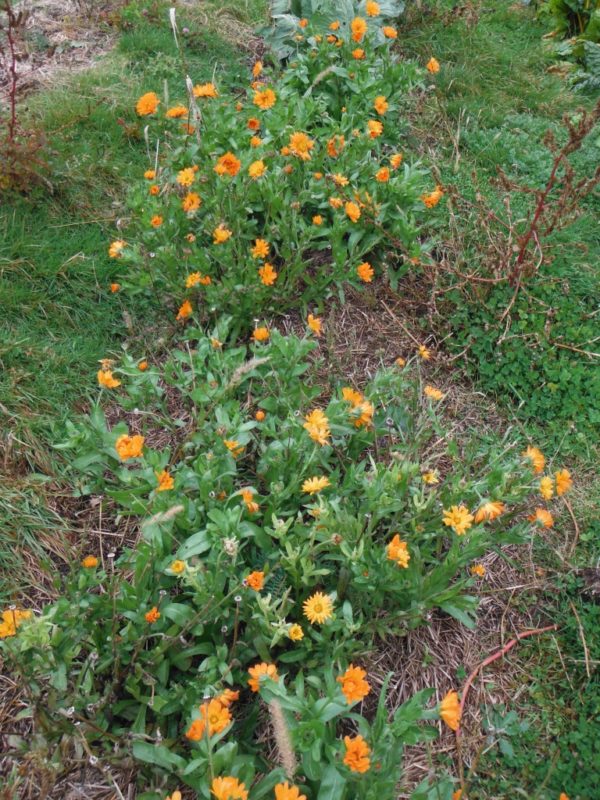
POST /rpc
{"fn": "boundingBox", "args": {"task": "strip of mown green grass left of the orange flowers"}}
[0,0,264,601]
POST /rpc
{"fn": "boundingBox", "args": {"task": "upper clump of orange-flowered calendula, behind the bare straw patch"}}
[109,0,432,332]
